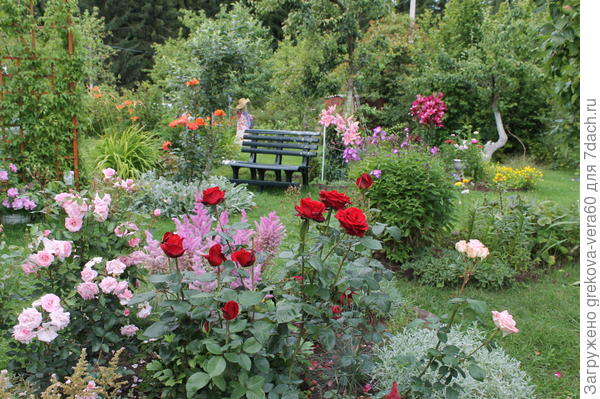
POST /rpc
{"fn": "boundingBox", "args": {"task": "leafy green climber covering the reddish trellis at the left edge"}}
[0,0,85,184]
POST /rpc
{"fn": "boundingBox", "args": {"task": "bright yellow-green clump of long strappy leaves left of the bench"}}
[87,126,160,178]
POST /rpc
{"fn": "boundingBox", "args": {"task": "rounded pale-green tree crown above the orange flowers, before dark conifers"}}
[151,3,271,115]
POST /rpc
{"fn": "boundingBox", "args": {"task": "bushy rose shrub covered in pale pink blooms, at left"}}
[9,169,149,386]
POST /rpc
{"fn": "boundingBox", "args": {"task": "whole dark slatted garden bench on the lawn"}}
[224,129,320,187]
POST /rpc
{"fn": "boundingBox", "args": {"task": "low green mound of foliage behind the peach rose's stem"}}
[402,248,515,288]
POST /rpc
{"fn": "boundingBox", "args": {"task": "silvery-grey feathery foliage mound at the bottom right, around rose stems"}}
[373,327,536,399]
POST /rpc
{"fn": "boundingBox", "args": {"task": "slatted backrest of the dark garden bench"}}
[242,129,320,166]
